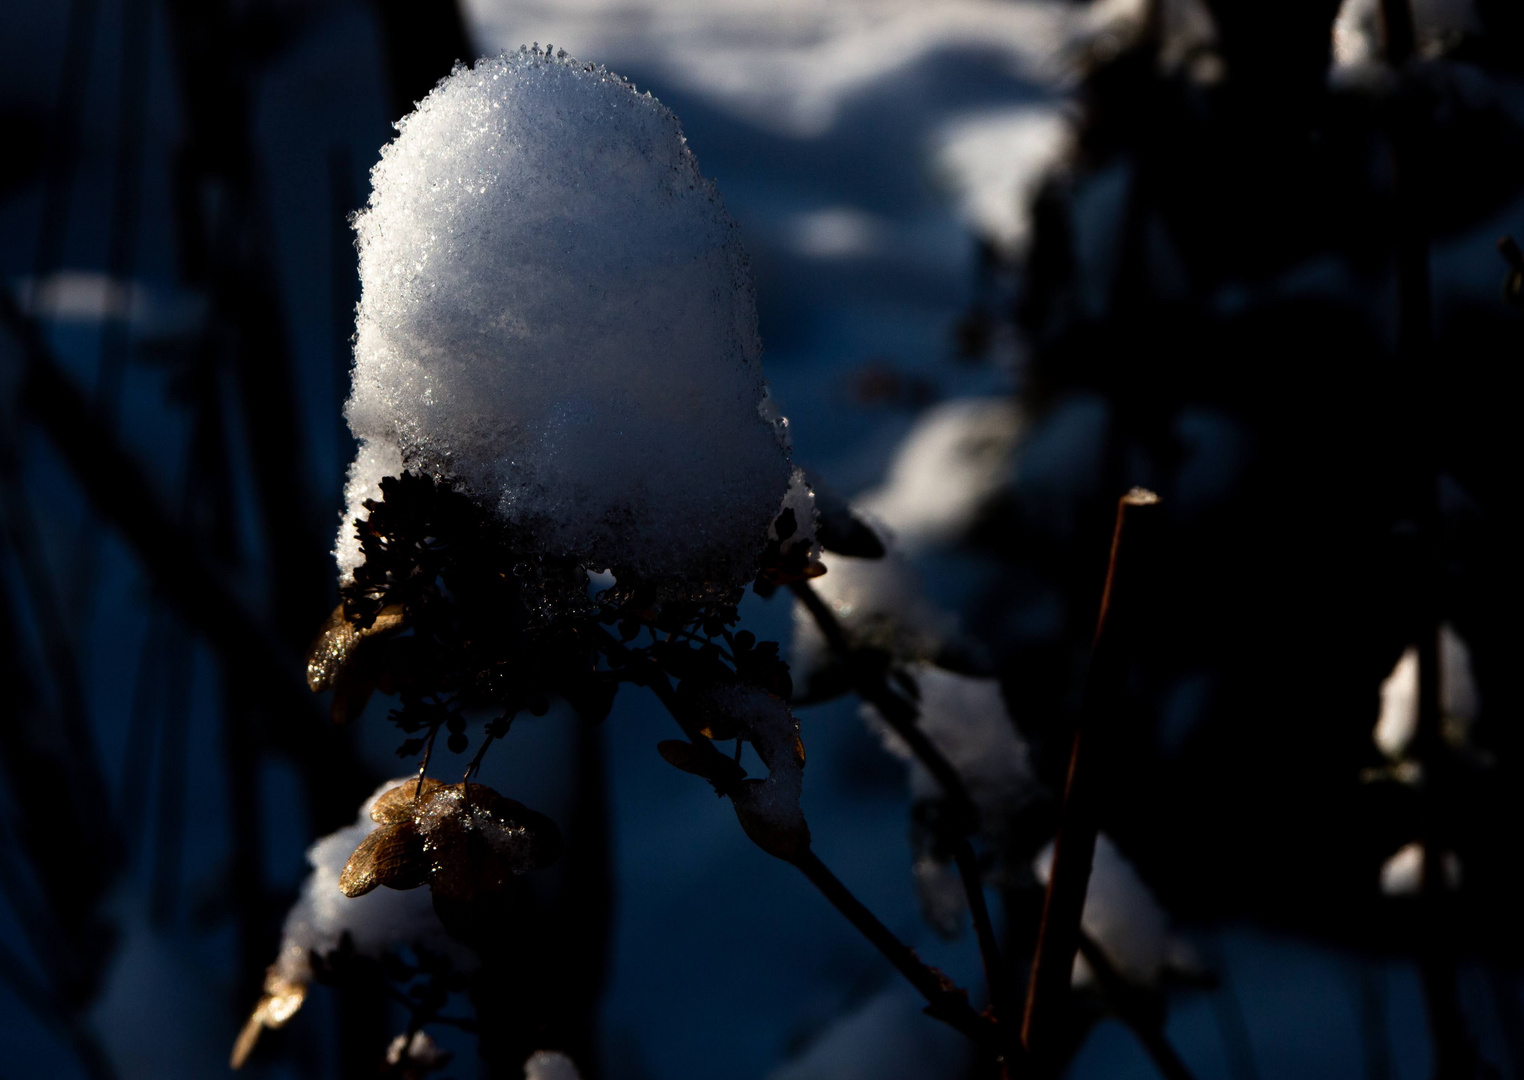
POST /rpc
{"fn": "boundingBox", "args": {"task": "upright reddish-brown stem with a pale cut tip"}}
[1021,487,1158,1057]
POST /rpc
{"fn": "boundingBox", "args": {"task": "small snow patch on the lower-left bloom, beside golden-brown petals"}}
[271,777,477,984]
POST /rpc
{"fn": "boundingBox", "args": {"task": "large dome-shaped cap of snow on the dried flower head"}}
[337,50,789,585]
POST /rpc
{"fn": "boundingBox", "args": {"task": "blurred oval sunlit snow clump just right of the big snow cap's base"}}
[853,398,1026,550]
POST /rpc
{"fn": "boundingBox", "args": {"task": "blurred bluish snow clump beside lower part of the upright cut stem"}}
[1032,833,1198,986]
